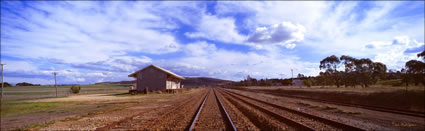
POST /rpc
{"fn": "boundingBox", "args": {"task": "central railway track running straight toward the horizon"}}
[188,89,237,131]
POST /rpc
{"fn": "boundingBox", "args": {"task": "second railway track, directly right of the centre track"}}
[220,89,363,130]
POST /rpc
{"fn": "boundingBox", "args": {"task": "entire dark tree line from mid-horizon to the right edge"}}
[234,51,425,88]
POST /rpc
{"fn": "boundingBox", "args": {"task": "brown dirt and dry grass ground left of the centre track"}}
[1,89,199,131]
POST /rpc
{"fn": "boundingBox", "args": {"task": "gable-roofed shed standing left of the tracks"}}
[128,65,184,92]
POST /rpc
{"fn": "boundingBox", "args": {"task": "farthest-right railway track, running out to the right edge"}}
[235,90,425,118]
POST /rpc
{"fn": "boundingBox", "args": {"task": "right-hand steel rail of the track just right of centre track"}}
[223,90,364,131]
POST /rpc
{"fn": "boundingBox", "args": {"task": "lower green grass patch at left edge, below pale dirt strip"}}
[1,100,72,116]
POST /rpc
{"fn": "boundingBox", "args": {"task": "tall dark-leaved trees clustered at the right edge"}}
[315,51,425,87]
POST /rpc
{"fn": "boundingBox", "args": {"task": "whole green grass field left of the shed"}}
[1,84,128,117]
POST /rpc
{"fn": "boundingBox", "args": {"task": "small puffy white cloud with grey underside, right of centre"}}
[248,22,305,49]
